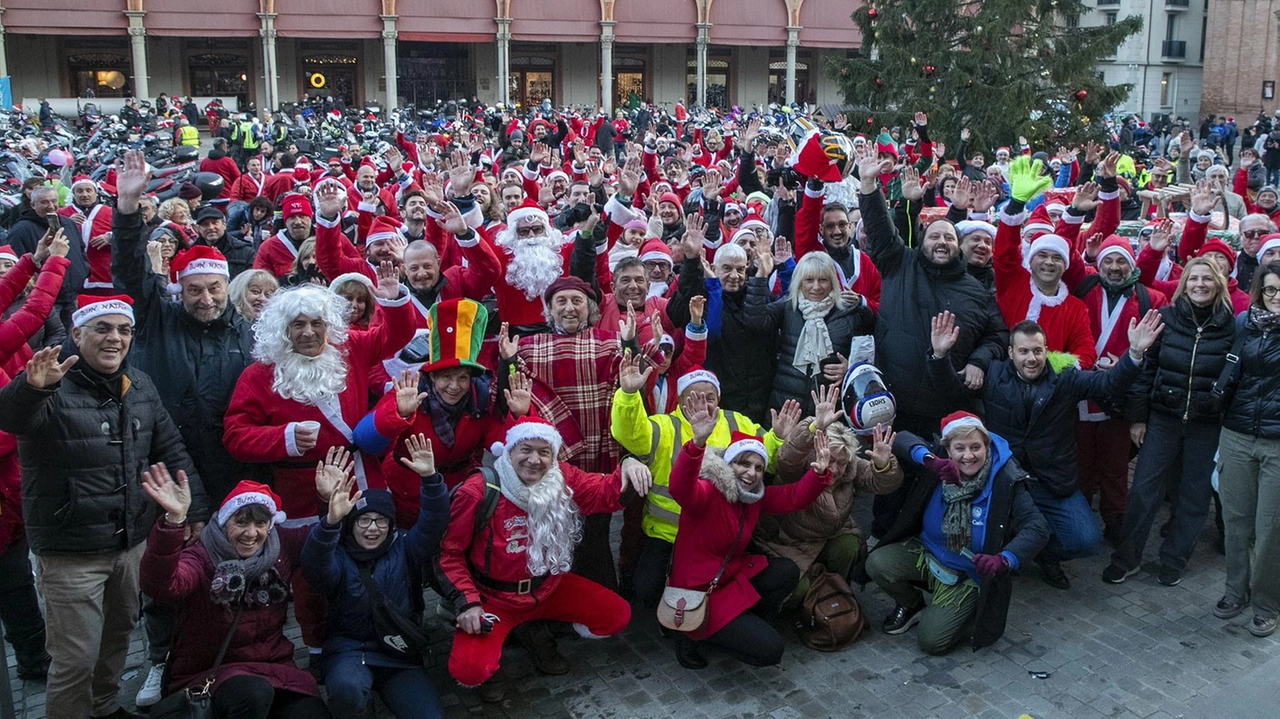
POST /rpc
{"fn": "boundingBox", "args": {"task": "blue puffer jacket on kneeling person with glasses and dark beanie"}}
[302,475,449,667]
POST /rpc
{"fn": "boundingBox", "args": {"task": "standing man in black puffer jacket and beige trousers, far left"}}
[0,296,209,719]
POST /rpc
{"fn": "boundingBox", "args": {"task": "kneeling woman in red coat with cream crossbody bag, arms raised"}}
[667,393,831,669]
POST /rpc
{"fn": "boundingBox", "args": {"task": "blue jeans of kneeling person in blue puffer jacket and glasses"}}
[325,651,444,719]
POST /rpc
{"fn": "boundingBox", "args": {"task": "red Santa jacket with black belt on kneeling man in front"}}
[435,462,622,614]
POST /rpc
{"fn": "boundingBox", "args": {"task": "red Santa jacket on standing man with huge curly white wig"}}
[223,287,413,523]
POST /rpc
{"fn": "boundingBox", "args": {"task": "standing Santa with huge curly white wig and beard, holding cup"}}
[223,280,413,647]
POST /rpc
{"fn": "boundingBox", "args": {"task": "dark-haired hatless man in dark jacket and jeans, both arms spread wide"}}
[928,311,1164,590]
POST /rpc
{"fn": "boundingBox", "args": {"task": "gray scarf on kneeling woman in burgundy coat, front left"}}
[200,521,289,606]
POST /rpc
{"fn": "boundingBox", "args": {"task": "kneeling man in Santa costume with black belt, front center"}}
[435,417,652,701]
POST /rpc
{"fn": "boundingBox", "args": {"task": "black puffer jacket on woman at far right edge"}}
[1222,315,1280,439]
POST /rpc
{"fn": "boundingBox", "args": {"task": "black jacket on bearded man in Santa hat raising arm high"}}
[859,184,1009,432]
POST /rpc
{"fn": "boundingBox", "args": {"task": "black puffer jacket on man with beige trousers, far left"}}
[0,355,209,555]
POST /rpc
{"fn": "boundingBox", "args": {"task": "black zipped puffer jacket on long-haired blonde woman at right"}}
[1125,297,1235,423]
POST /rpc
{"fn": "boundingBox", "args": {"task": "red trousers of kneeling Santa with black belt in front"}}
[449,573,631,687]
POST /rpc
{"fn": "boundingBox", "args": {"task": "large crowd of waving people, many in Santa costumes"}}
[0,96,1280,719]
